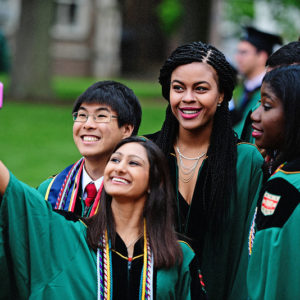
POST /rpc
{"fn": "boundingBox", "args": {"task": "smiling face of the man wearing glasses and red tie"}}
[73,103,133,161]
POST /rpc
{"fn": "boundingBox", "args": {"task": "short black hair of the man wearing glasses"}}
[72,81,142,135]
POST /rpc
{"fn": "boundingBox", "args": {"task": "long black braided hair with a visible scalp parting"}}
[155,42,237,229]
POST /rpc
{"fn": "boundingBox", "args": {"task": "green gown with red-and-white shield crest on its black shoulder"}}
[247,174,300,300]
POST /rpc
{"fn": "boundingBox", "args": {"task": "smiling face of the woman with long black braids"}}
[170,62,224,130]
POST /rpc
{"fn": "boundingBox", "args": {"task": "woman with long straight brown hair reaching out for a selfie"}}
[0,137,206,300]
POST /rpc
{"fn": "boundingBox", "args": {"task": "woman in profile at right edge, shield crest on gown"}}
[247,66,300,300]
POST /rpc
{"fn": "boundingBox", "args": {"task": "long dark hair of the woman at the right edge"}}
[263,65,300,169]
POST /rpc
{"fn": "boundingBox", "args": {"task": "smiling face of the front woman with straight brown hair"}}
[104,142,150,201]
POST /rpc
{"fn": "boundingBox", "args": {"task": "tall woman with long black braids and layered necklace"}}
[147,42,263,300]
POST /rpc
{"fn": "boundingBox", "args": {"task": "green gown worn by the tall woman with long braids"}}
[147,132,263,300]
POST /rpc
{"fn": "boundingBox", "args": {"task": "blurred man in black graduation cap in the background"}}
[231,26,282,137]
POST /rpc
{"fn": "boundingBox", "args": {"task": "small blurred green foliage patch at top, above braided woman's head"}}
[156,0,183,34]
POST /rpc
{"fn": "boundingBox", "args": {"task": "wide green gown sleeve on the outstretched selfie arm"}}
[0,174,97,299]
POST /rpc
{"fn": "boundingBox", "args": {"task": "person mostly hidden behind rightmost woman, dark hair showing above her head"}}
[241,41,300,144]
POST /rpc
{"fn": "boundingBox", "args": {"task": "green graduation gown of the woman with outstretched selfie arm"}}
[0,174,206,300]
